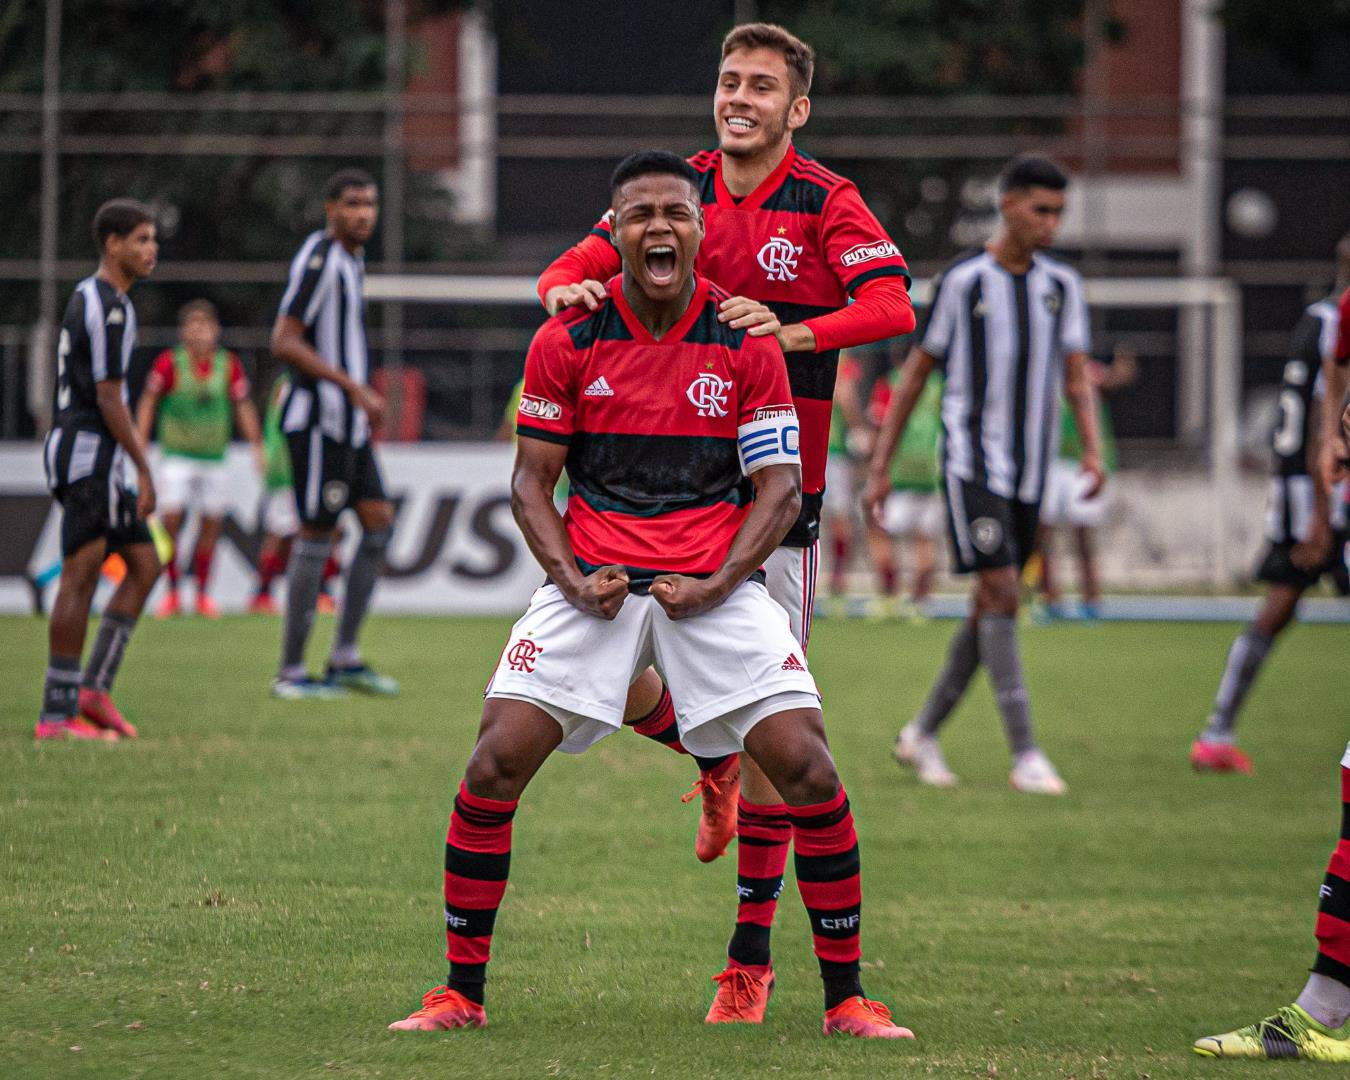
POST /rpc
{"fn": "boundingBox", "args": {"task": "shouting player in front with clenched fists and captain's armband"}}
[392,151,911,1038]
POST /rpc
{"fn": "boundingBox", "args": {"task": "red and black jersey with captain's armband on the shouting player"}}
[516,275,798,590]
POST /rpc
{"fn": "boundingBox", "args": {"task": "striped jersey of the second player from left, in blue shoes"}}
[281,231,370,447]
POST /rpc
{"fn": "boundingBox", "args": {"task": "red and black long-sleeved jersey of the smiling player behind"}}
[539,147,914,547]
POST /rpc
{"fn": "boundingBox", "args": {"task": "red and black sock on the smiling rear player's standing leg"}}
[726,795,792,968]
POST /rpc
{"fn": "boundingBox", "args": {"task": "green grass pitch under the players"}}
[0,618,1350,1079]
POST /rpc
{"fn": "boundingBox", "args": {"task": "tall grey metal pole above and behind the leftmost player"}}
[28,0,61,431]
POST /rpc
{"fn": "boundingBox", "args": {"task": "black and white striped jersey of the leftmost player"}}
[43,275,136,489]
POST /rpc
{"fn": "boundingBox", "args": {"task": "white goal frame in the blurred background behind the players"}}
[366,274,1242,589]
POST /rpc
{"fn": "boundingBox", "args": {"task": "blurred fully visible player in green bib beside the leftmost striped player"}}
[136,300,263,618]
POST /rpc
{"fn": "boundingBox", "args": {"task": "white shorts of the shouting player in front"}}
[485,582,821,757]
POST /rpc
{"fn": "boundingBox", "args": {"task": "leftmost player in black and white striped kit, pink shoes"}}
[34,198,159,740]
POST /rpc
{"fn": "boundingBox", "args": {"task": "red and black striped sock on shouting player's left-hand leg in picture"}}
[446,783,518,1004]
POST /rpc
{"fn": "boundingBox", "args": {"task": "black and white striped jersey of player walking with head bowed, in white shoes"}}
[921,251,1091,502]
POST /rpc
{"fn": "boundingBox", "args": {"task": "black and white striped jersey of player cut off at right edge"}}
[1266,297,1346,544]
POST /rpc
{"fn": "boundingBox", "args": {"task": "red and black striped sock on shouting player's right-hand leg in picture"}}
[787,787,863,1008]
